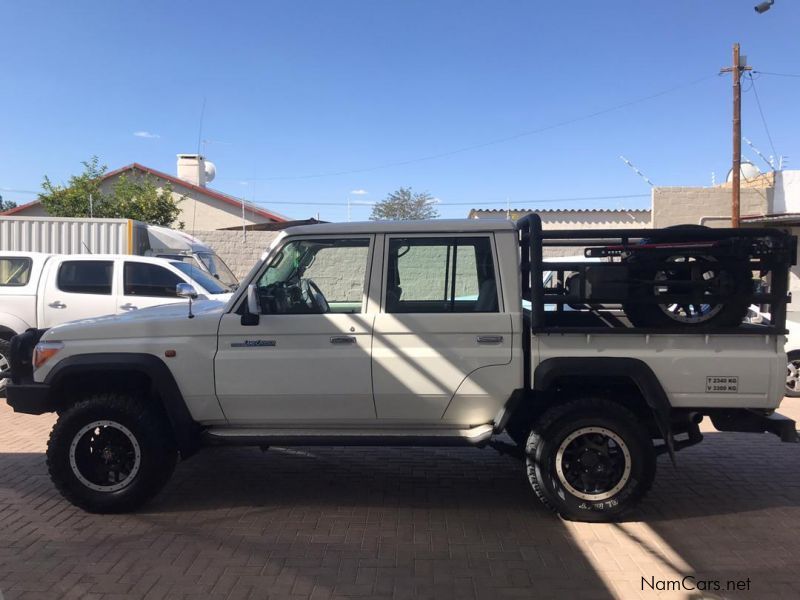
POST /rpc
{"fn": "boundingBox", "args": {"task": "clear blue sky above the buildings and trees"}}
[0,0,800,220]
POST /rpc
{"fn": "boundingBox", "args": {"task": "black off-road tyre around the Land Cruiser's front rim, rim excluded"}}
[47,393,178,513]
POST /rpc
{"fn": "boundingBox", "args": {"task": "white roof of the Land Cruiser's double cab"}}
[284,219,515,235]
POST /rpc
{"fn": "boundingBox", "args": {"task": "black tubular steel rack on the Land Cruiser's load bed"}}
[516,214,797,340]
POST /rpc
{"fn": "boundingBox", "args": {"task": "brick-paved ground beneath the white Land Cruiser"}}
[0,400,800,600]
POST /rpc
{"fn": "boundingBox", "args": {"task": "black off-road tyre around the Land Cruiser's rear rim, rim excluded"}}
[525,398,656,523]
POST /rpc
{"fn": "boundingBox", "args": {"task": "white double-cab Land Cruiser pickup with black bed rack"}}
[7,215,797,521]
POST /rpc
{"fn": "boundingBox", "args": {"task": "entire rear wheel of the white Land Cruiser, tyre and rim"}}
[526,398,656,522]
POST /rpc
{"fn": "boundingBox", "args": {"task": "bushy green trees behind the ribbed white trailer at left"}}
[39,156,184,226]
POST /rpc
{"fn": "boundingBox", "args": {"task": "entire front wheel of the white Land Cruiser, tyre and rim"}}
[47,393,178,513]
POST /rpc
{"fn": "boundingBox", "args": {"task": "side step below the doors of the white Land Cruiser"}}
[204,424,494,446]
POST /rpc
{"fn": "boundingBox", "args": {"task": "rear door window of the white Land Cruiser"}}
[384,237,498,313]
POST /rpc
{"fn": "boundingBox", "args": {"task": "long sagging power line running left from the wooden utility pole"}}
[227,73,717,181]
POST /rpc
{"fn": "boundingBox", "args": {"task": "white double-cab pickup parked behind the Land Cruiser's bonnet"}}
[0,252,231,392]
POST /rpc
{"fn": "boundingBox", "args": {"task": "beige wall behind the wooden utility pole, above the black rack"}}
[652,186,774,227]
